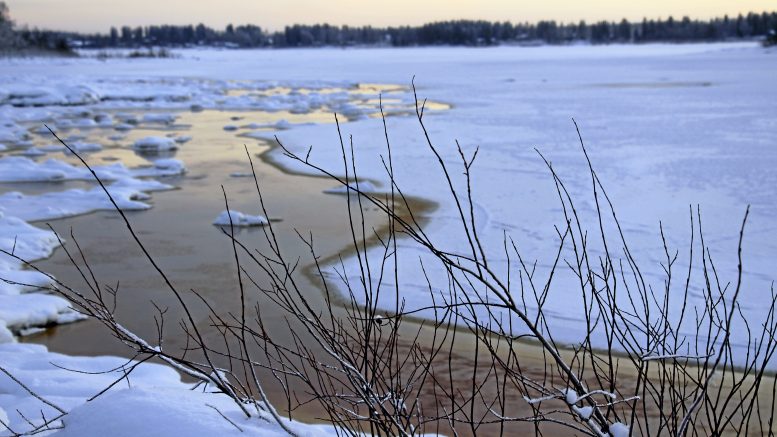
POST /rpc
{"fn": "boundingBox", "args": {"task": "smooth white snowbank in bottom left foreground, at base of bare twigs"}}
[0,343,334,437]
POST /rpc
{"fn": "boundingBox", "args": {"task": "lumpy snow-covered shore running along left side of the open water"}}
[0,51,422,435]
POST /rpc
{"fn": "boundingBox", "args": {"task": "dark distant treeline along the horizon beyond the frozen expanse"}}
[0,1,777,49]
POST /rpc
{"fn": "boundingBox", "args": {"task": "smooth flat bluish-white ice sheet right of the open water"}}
[224,44,777,368]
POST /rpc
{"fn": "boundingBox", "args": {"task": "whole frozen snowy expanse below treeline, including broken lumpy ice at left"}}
[0,43,777,432]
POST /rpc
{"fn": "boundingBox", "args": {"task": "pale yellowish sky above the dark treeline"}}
[5,0,777,33]
